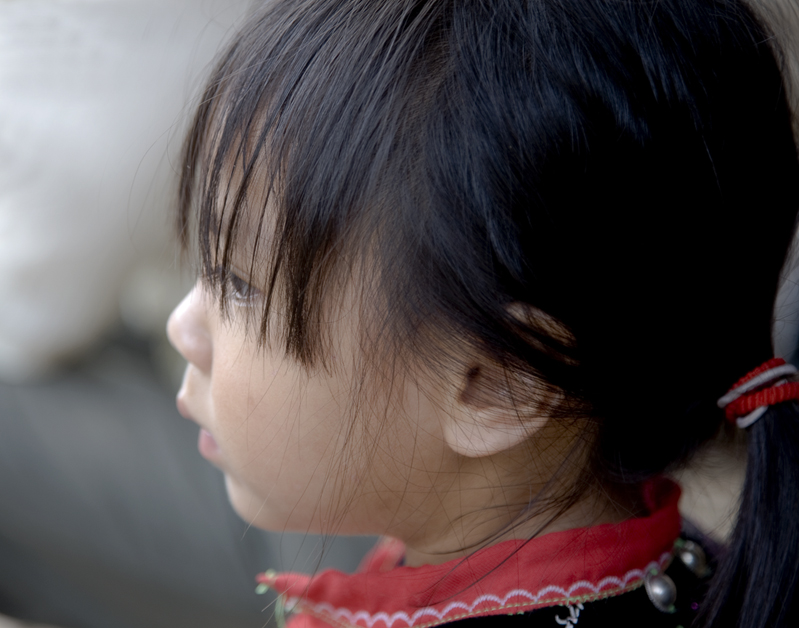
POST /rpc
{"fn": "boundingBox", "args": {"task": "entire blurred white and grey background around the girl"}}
[0,0,799,628]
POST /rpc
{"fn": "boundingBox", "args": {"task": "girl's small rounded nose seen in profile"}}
[166,282,213,373]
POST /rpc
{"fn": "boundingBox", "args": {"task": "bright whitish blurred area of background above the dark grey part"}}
[0,0,234,381]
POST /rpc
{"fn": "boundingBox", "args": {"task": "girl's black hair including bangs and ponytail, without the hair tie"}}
[179,0,799,628]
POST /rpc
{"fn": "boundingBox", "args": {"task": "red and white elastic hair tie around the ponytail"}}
[718,358,799,428]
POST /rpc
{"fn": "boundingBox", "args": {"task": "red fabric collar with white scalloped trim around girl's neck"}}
[257,478,680,628]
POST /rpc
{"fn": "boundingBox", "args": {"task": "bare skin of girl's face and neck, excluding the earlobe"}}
[167,270,629,565]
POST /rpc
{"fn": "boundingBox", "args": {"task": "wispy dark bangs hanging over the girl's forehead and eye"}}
[179,2,450,365]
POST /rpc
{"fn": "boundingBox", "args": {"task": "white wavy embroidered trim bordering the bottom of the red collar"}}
[286,552,671,628]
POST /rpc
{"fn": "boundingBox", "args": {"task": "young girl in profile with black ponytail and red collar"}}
[169,0,799,628]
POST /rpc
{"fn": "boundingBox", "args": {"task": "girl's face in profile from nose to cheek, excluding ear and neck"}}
[167,282,455,538]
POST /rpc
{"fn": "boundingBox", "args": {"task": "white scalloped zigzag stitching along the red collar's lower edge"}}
[286,552,671,628]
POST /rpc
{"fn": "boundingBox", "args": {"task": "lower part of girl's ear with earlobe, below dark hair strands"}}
[443,359,552,458]
